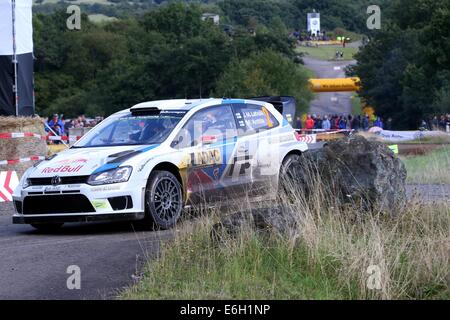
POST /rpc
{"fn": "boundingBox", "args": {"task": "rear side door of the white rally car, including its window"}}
[233,104,279,193]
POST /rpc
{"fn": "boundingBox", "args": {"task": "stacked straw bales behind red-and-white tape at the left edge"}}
[0,117,48,177]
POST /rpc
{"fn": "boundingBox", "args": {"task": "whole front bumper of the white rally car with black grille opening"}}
[12,183,145,224]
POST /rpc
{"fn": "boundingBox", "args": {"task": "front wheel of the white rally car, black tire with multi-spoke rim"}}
[145,171,183,229]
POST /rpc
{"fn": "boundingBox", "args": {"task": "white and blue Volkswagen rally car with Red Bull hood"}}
[13,99,308,229]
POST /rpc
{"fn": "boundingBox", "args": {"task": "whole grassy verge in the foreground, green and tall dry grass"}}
[119,176,450,300]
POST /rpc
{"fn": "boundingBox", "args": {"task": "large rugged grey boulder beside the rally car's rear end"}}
[302,135,406,212]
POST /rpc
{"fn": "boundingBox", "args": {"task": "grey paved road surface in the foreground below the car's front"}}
[0,203,173,300]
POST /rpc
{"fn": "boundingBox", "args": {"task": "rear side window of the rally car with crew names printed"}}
[234,105,279,134]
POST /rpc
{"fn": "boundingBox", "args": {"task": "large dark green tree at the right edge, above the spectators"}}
[352,0,450,129]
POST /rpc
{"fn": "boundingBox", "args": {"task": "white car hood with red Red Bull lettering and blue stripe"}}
[29,145,158,178]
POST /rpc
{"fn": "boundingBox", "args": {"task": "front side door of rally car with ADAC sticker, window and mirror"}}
[171,105,237,202]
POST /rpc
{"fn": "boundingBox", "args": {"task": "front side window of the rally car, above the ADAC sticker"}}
[172,105,237,148]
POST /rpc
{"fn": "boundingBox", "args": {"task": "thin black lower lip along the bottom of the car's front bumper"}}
[13,212,145,224]
